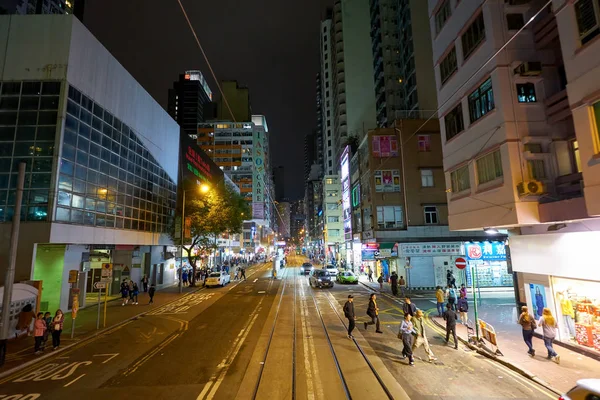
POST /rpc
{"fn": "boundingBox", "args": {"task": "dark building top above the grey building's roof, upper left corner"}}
[0,0,85,21]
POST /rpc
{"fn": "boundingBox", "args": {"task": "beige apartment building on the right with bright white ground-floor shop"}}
[429,0,600,351]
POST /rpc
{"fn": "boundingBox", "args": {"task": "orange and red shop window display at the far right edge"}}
[553,278,600,351]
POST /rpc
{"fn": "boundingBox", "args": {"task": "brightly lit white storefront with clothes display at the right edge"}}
[510,231,600,353]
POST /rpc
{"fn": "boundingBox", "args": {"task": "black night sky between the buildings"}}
[84,0,331,199]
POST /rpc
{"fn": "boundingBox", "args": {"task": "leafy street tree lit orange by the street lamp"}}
[170,183,250,286]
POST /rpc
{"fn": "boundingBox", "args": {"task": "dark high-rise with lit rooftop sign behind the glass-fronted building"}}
[167,70,212,138]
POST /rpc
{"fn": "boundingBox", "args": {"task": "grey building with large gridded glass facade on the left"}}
[0,15,188,311]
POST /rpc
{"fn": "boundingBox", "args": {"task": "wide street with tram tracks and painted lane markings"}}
[0,256,556,400]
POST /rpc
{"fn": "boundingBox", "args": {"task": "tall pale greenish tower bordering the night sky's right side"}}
[330,0,377,162]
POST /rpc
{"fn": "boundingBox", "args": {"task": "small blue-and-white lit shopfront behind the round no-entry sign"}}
[464,241,513,288]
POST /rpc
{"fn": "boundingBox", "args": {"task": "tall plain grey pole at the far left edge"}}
[0,162,27,365]
